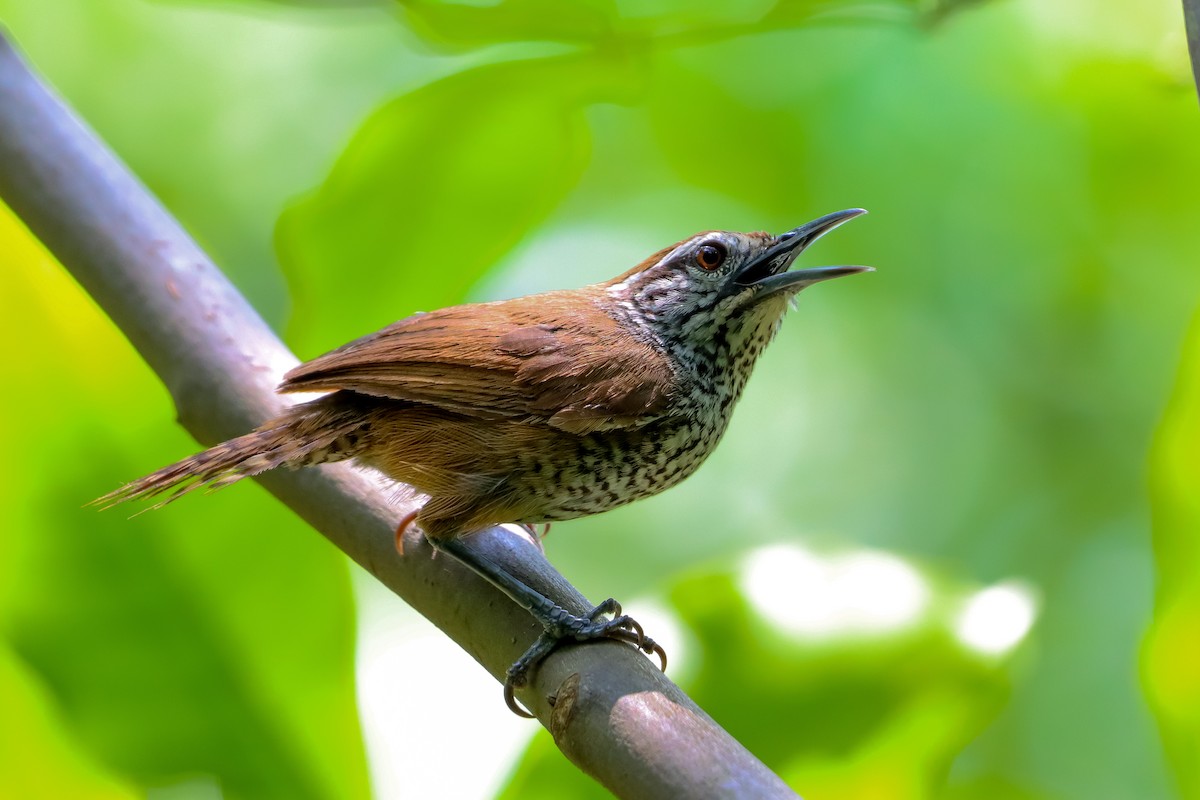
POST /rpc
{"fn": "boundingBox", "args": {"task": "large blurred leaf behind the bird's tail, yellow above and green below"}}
[0,206,367,798]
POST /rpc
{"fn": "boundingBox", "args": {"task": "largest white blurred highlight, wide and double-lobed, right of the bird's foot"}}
[740,545,930,638]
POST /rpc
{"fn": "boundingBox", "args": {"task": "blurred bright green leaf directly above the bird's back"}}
[277,59,608,354]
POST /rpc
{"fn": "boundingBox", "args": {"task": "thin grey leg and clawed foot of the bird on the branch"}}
[431,539,667,717]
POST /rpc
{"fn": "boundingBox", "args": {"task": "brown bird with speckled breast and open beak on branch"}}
[96,209,870,714]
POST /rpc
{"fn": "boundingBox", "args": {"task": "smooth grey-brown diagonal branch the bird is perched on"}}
[0,31,796,798]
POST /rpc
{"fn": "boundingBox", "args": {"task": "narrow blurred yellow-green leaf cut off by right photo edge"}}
[1142,318,1200,798]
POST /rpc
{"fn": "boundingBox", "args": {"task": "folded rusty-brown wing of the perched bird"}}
[280,290,672,433]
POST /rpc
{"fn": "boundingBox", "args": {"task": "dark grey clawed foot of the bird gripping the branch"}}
[504,597,667,718]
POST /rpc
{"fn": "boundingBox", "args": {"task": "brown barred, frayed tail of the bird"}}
[88,392,370,509]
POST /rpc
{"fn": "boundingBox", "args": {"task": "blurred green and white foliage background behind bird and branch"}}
[0,0,1200,800]
